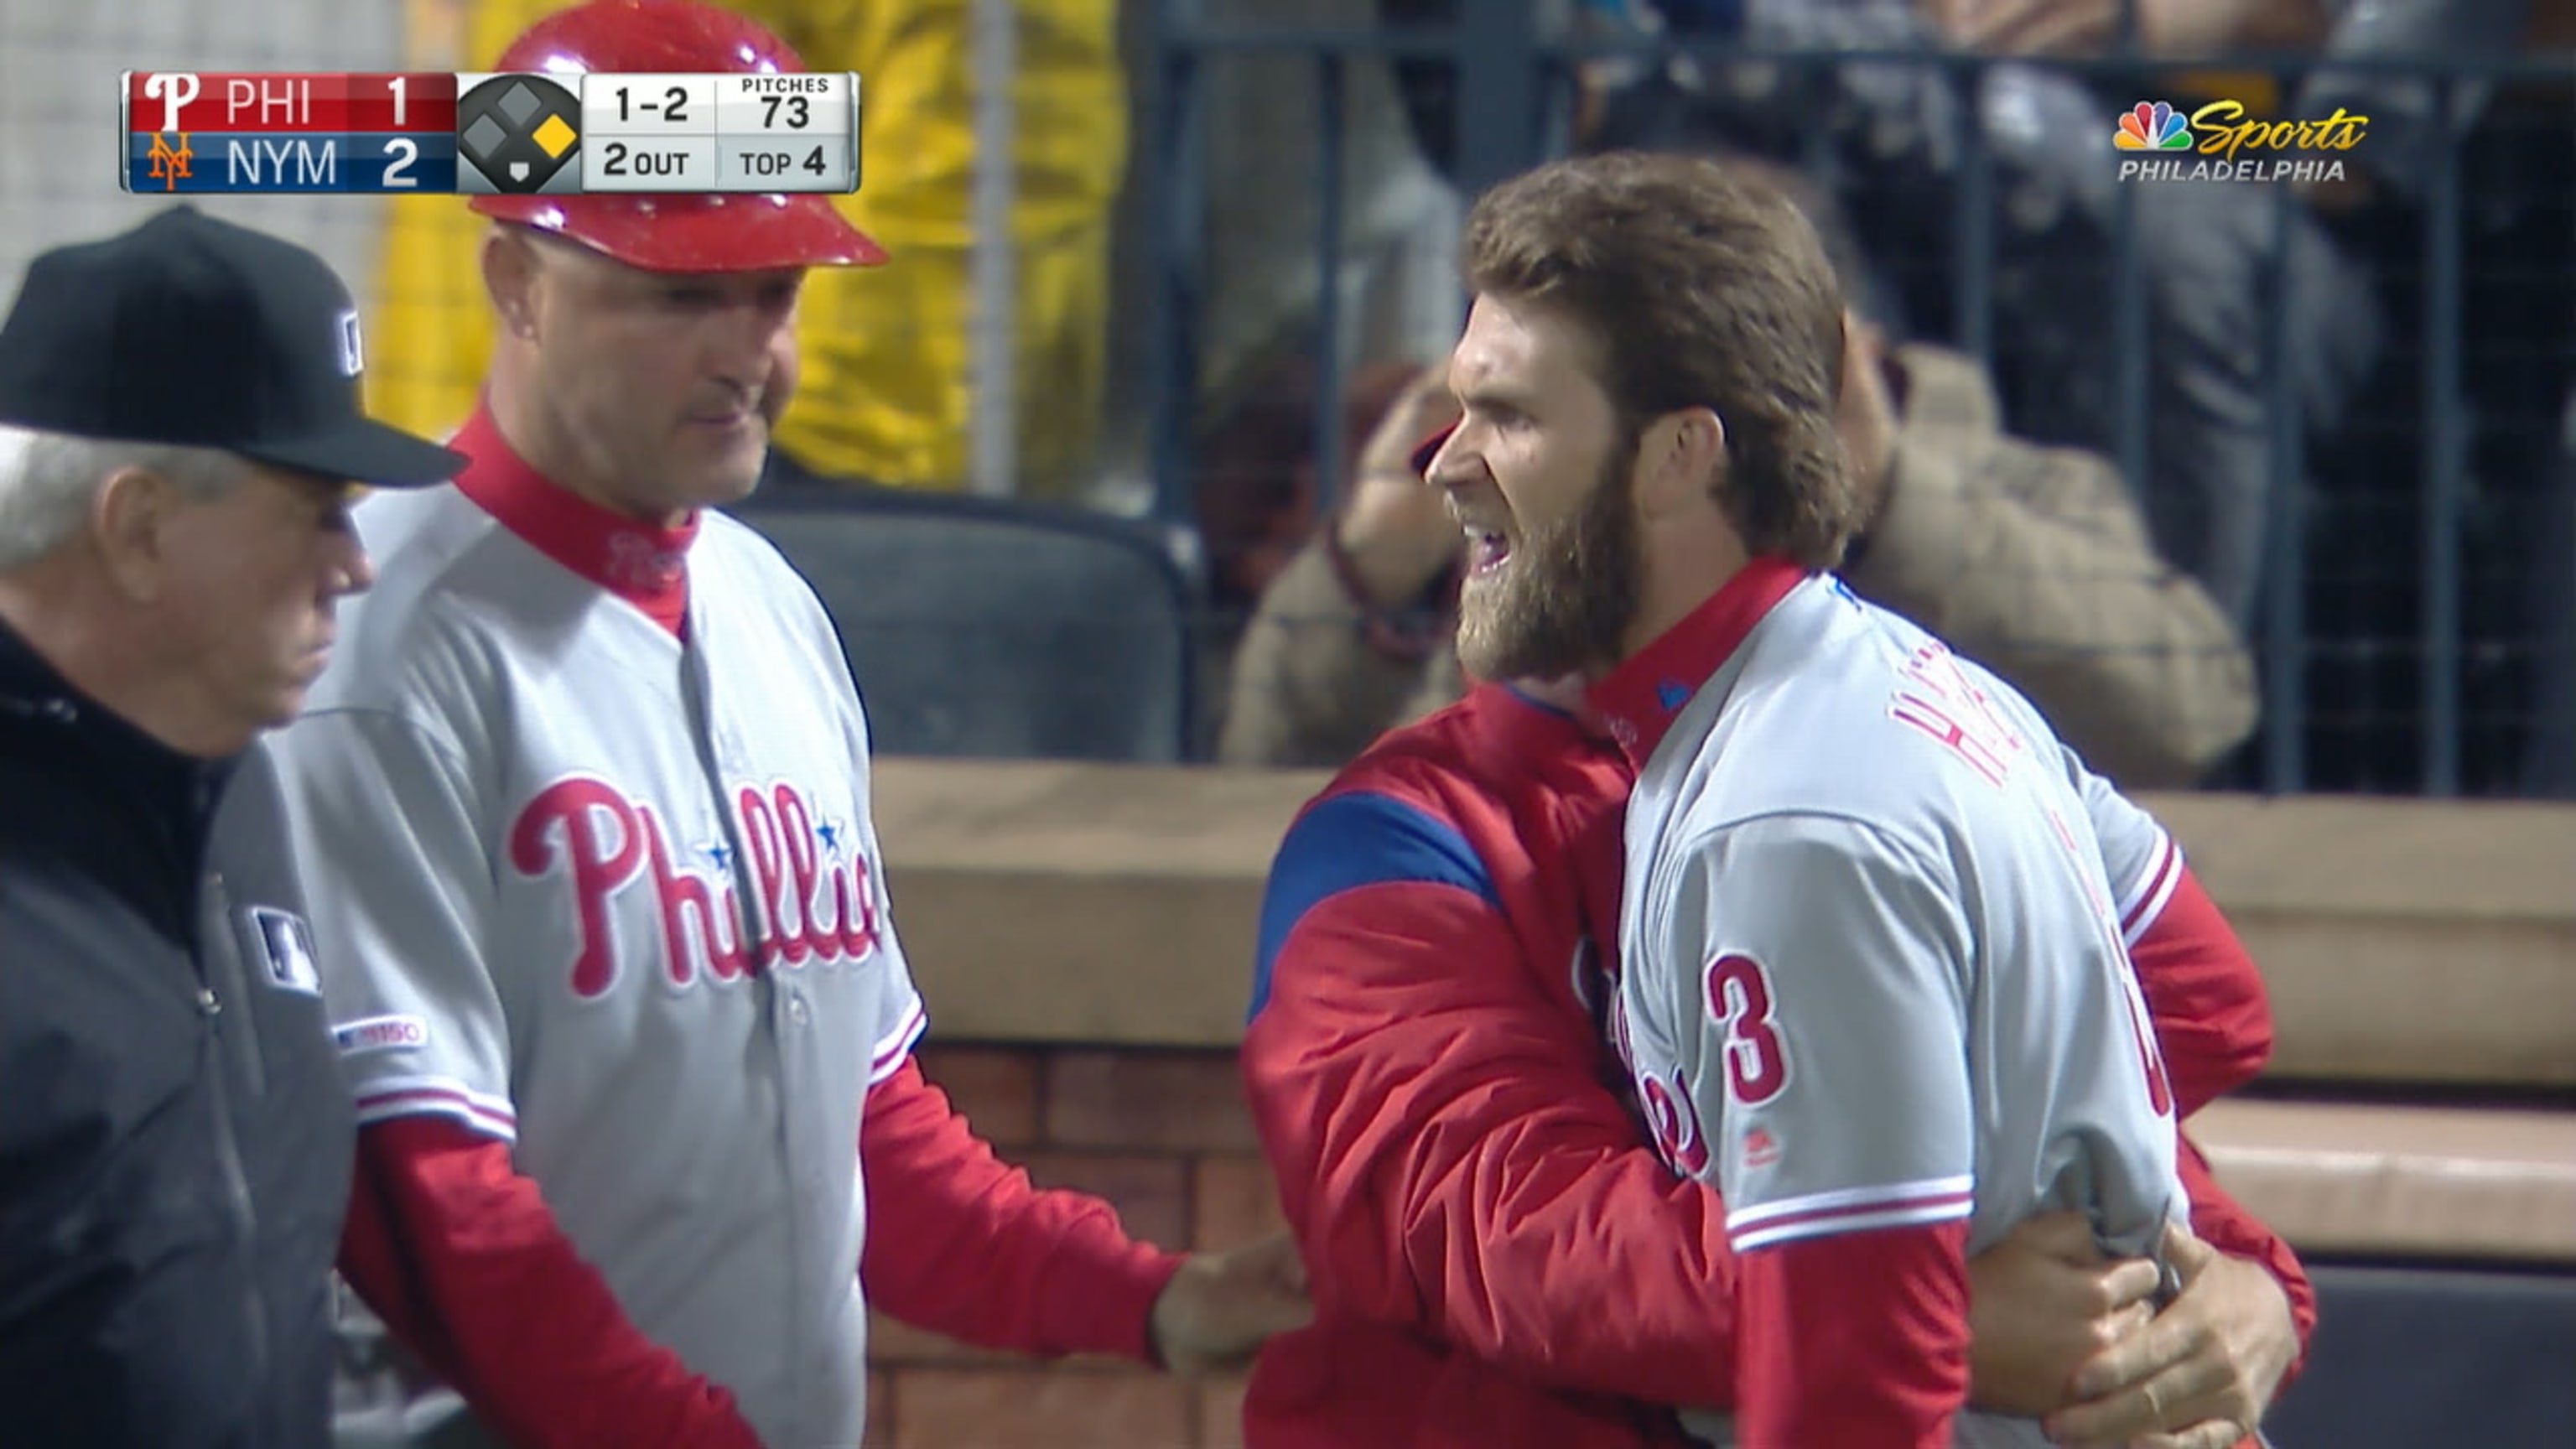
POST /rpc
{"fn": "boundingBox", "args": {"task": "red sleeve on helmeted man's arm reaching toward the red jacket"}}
[858,1041,1180,1361]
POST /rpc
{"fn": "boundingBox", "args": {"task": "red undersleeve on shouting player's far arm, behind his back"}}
[2127,869,2272,1116]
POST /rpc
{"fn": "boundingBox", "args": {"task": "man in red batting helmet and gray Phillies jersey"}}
[281,0,1306,1449]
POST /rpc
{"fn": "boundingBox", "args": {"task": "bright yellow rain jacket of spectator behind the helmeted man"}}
[377,0,1129,495]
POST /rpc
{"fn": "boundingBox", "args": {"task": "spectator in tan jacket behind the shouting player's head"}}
[1218,163,2257,789]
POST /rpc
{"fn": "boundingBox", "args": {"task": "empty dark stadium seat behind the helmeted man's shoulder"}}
[731,464,1195,763]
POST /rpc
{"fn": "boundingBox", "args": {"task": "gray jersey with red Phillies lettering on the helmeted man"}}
[261,485,922,1449]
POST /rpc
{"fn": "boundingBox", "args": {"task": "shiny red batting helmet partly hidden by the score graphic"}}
[471,0,886,271]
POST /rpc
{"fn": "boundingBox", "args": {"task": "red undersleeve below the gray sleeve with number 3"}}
[1737,1219,1968,1449]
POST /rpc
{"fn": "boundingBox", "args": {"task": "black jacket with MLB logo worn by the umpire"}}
[0,613,356,1449]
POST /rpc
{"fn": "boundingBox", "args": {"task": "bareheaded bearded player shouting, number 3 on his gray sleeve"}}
[1430,154,2298,1449]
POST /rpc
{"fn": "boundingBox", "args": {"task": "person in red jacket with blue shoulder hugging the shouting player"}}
[1242,384,2316,1449]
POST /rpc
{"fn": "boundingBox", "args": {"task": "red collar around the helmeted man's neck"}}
[454,408,699,634]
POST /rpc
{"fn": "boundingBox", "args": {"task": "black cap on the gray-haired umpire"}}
[0,206,466,487]
